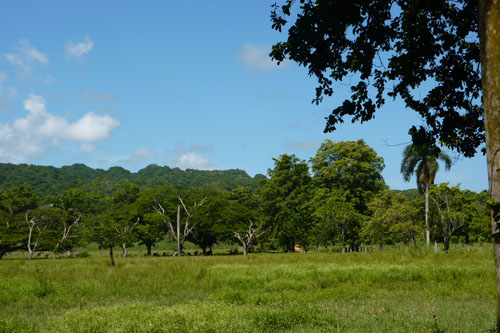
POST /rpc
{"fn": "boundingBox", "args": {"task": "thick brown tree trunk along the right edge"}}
[479,0,500,332]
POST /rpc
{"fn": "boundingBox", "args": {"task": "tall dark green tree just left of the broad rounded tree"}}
[259,154,312,252]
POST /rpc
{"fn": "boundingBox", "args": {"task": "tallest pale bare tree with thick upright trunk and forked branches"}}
[153,196,207,256]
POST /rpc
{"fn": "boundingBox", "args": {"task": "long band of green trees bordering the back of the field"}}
[0,140,491,262]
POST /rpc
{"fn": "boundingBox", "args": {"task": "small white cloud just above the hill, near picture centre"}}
[167,141,214,170]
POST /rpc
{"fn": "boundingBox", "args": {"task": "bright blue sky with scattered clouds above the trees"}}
[0,0,488,191]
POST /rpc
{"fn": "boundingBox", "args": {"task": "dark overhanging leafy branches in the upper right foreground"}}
[271,0,485,157]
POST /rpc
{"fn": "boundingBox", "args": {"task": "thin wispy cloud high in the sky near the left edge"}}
[4,39,49,77]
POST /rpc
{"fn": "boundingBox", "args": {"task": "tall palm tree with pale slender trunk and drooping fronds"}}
[401,144,452,245]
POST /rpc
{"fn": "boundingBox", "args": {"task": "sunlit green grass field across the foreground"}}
[0,245,495,332]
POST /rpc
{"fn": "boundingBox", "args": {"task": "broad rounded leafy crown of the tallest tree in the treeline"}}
[311,140,385,213]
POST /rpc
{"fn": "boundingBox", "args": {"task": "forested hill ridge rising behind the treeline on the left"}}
[0,163,264,195]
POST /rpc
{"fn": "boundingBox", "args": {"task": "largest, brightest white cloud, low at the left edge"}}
[0,94,120,163]
